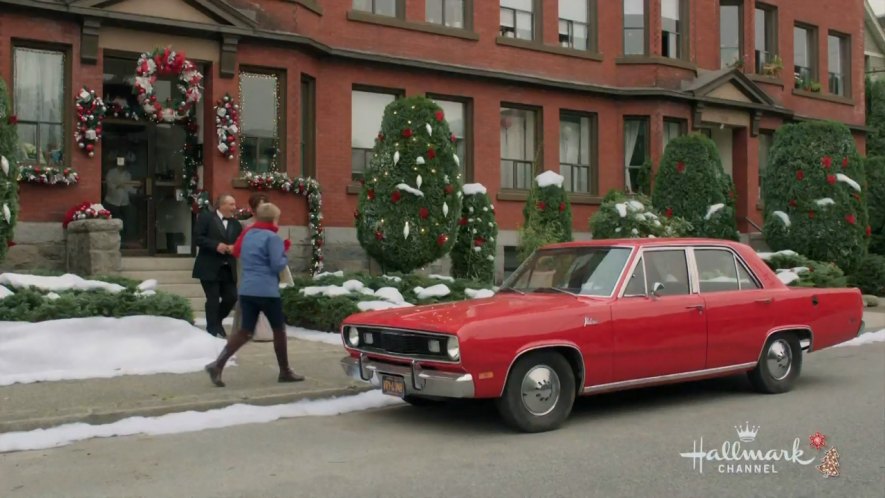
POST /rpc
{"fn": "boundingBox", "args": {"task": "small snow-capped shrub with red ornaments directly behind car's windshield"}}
[522,171,572,242]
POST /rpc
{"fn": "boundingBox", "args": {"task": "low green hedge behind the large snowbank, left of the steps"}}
[0,288,194,323]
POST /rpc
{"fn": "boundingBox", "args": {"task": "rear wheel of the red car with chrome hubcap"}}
[749,334,802,394]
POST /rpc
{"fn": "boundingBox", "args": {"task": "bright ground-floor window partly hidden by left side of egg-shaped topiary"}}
[350,90,397,180]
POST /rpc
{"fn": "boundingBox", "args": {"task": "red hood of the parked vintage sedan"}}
[344,293,602,333]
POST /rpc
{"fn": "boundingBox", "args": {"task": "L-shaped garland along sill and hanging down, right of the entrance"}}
[242,172,326,275]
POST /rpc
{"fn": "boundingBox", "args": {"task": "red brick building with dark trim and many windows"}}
[0,0,865,280]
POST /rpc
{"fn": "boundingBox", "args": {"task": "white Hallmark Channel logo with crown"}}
[679,422,815,474]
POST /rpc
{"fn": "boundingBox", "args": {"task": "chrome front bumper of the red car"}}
[341,354,474,398]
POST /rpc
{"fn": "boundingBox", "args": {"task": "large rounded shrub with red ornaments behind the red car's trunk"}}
[762,121,869,273]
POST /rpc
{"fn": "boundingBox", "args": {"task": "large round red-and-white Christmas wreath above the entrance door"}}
[134,47,203,123]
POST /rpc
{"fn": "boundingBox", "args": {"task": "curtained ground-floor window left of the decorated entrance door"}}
[12,47,68,166]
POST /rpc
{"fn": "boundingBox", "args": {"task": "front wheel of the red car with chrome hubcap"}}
[497,351,575,432]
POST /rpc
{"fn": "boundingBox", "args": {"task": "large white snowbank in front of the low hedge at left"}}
[0,316,224,386]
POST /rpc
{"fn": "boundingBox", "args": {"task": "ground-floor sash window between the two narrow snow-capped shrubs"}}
[501,107,537,190]
